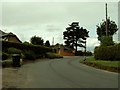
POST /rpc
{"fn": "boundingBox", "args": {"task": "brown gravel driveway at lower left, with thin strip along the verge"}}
[0,59,48,88]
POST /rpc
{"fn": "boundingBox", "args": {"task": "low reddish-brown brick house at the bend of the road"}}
[53,45,75,56]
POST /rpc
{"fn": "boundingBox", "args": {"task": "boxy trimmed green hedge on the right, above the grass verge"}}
[94,44,120,60]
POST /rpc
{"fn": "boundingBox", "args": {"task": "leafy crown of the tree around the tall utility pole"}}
[97,18,118,41]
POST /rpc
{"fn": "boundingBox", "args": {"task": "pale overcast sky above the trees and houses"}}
[0,0,118,51]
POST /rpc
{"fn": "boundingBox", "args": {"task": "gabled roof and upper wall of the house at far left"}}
[0,30,22,43]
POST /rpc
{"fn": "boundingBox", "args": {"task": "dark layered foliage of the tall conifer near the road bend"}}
[63,22,89,51]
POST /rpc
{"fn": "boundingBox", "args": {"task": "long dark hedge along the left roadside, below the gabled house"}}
[2,41,52,59]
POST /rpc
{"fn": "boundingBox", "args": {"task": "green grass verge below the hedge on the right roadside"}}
[80,56,120,73]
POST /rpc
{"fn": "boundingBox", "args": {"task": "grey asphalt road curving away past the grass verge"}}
[18,57,118,88]
